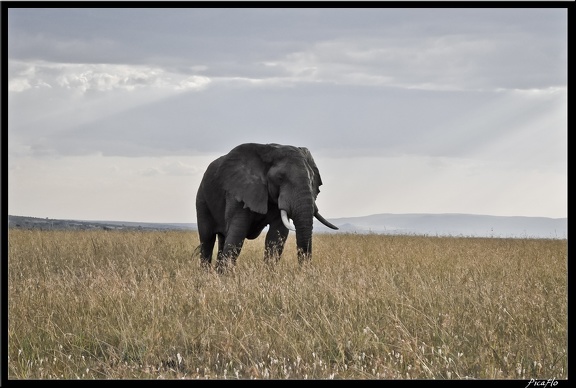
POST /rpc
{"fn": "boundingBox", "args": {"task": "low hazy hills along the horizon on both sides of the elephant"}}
[8,214,568,239]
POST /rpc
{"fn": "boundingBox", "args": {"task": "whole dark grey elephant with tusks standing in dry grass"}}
[196,143,338,272]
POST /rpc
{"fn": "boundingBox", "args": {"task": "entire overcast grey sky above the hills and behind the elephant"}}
[8,8,568,222]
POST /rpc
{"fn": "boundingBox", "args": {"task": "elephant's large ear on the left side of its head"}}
[219,144,268,214]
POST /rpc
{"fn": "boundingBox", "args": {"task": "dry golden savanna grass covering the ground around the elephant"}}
[7,229,568,379]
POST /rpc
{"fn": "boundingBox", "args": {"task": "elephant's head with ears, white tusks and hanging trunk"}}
[221,143,338,259]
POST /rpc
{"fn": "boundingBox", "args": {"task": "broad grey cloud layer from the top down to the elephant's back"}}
[8,9,567,168]
